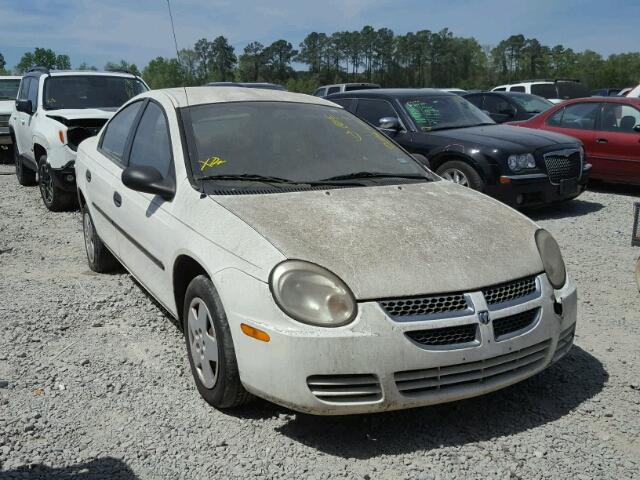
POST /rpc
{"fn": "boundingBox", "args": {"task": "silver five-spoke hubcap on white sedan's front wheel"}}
[187,297,218,389]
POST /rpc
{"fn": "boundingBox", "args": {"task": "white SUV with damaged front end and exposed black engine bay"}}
[9,68,149,211]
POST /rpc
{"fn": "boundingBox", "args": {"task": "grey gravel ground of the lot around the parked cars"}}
[0,162,640,480]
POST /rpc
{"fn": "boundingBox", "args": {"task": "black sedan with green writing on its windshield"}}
[327,89,591,207]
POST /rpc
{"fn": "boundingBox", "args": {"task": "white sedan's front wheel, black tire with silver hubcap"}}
[182,275,251,409]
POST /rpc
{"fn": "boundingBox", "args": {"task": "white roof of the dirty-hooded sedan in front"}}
[154,86,338,108]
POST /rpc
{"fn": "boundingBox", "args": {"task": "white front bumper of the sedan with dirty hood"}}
[216,273,577,415]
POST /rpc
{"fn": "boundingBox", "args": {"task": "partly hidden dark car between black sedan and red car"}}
[463,92,554,123]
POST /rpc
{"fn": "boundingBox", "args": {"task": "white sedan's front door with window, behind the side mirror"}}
[117,100,176,305]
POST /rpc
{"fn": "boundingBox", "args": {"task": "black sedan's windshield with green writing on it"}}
[404,95,495,132]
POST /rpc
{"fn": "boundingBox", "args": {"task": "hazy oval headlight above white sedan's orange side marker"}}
[269,260,358,327]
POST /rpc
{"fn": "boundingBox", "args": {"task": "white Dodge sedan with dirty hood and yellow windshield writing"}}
[76,87,576,415]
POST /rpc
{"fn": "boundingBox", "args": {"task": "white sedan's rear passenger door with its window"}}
[85,101,144,258]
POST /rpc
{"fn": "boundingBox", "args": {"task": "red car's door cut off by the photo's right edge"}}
[591,102,640,183]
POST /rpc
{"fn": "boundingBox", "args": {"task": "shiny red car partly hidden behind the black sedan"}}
[511,97,640,185]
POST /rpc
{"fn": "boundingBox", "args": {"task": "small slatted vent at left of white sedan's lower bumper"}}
[307,375,382,403]
